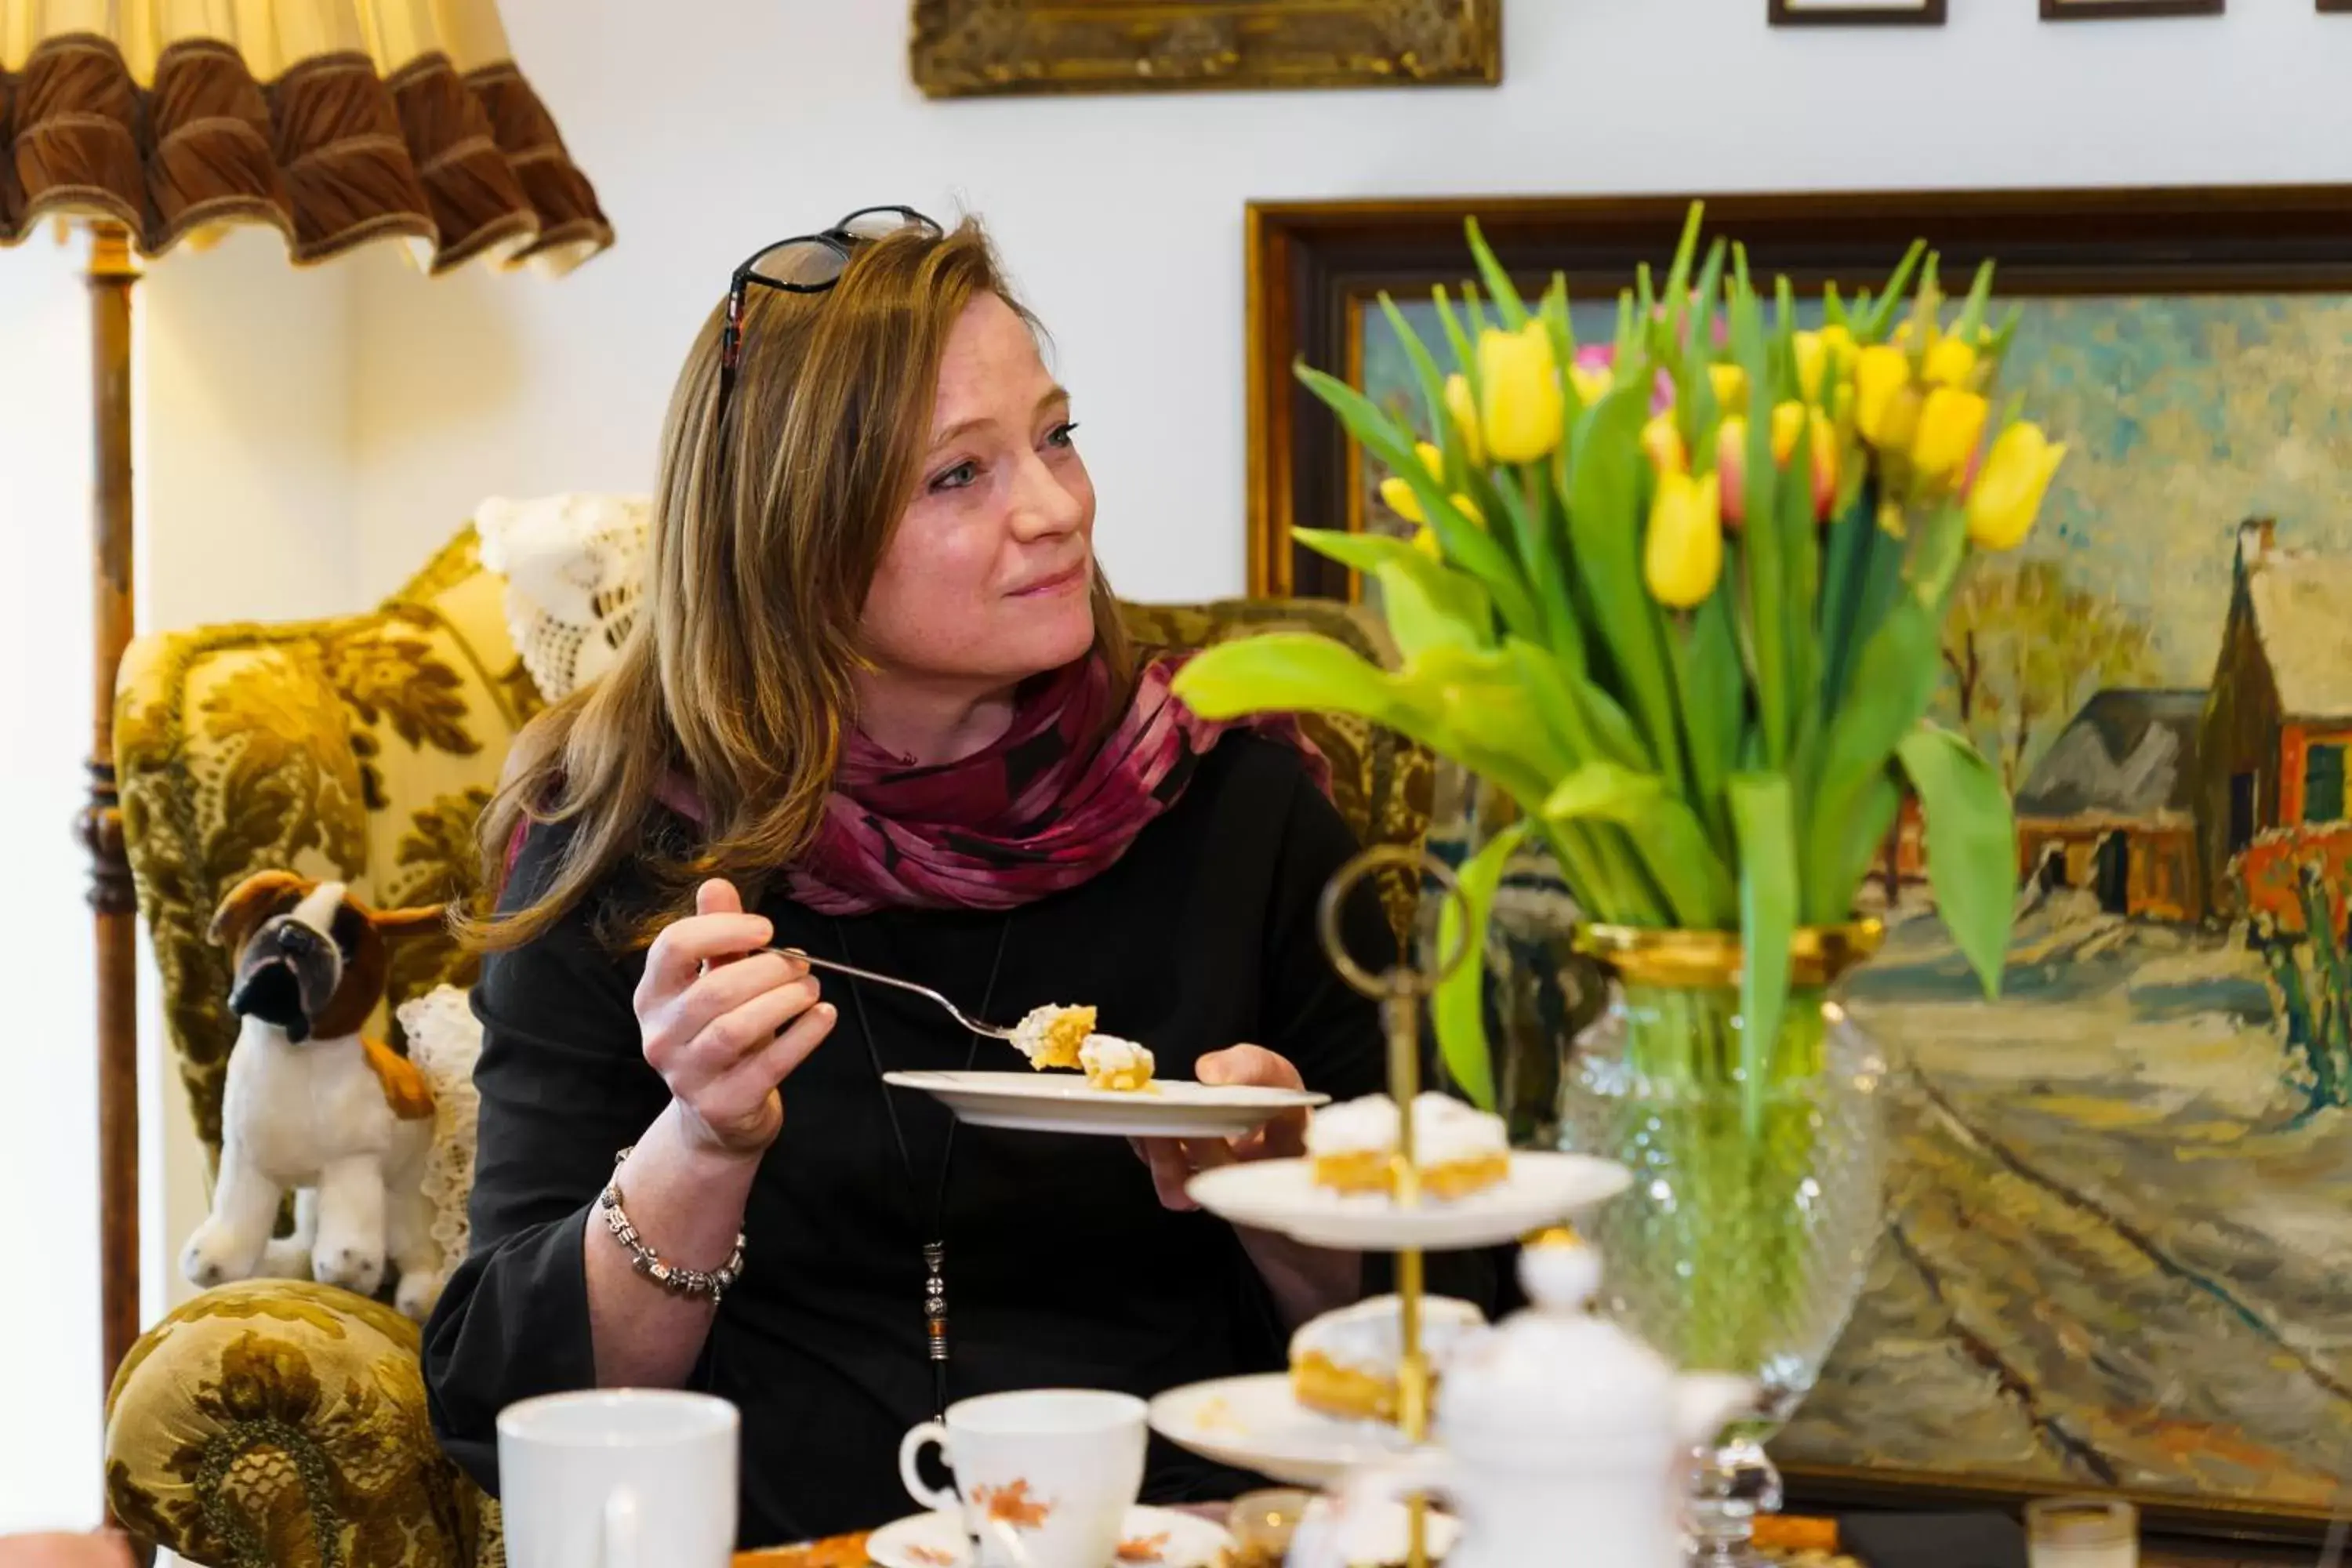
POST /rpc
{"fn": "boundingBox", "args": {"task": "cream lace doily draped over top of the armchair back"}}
[473,494,654,703]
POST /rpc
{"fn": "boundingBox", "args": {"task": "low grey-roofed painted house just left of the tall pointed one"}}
[2018,687,2206,921]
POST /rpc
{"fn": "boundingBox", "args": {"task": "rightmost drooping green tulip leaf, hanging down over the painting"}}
[1896,724,2018,996]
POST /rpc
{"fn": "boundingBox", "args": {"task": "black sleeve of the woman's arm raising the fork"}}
[423,827,670,1495]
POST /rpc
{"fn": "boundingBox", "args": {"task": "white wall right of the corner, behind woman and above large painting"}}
[355,0,2352,600]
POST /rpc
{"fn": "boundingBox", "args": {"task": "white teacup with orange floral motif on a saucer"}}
[898,1389,1145,1568]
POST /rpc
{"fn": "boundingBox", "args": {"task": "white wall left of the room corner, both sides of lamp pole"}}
[0,223,358,1533]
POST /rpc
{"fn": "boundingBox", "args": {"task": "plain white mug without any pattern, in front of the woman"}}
[499,1389,741,1568]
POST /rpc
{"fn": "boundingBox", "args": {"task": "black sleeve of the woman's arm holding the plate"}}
[1261,767,1512,1314]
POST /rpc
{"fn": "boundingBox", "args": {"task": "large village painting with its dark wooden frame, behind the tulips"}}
[1249,188,2352,1535]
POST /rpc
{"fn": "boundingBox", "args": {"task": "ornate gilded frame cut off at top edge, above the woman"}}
[908,0,1503,99]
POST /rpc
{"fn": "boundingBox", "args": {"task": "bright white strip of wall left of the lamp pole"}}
[0,238,103,1533]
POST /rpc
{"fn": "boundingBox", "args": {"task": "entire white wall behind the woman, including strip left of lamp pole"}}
[0,0,2352,1530]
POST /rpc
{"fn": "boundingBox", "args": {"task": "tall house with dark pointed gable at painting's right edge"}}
[2197,517,2352,912]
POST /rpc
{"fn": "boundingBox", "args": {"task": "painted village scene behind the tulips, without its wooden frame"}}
[1362,294,2352,1516]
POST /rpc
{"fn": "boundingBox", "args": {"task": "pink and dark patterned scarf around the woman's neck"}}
[663,654,1331,914]
